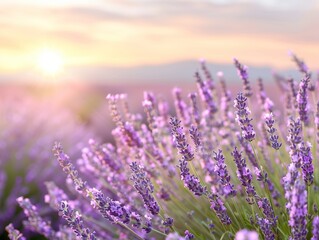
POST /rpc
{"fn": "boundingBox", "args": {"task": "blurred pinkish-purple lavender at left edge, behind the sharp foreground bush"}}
[0,95,90,239]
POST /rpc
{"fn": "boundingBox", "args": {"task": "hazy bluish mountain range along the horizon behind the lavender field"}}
[0,60,308,83]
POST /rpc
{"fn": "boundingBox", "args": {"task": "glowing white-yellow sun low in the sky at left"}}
[36,49,63,76]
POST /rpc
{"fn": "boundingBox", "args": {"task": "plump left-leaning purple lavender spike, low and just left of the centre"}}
[130,162,160,215]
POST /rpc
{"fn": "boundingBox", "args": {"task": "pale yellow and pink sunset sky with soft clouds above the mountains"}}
[0,0,319,82]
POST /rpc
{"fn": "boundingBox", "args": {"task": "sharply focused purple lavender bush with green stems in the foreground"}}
[7,55,319,240]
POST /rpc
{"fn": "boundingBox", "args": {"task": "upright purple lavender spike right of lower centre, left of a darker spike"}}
[214,149,236,197]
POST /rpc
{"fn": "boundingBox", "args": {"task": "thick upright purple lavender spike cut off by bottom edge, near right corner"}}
[289,181,308,240]
